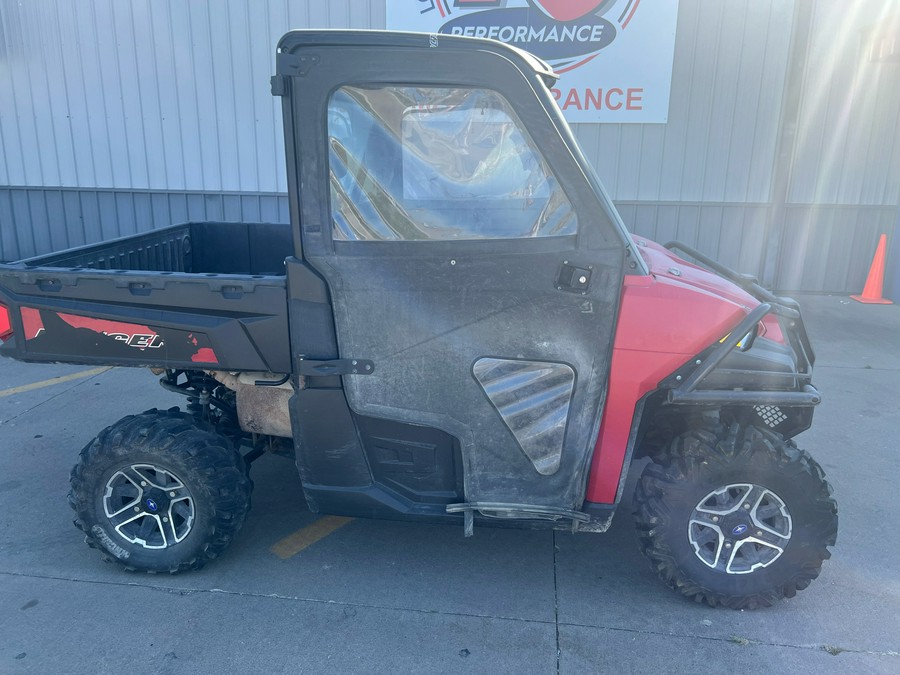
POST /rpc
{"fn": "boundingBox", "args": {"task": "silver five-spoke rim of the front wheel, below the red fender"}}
[688,483,793,574]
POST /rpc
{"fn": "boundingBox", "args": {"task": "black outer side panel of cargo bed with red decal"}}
[0,265,291,373]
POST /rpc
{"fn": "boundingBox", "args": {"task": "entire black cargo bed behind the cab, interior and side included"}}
[0,222,292,373]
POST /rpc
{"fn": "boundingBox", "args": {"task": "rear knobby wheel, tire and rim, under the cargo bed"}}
[69,408,252,574]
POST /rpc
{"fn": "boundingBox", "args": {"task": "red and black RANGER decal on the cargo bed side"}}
[22,307,219,363]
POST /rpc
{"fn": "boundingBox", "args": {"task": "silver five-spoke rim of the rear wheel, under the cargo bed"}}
[103,464,195,549]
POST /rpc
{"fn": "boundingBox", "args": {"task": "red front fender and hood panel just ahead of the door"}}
[586,238,782,504]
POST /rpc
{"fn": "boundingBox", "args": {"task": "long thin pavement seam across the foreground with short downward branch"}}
[0,571,900,661]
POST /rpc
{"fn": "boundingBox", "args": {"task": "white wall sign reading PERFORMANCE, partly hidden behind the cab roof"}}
[387,0,678,124]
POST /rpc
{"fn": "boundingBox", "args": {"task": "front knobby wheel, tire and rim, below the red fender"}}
[634,424,838,609]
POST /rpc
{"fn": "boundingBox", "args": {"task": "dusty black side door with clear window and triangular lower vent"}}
[282,34,626,522]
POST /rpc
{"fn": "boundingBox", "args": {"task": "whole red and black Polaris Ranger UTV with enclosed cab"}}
[0,31,837,608]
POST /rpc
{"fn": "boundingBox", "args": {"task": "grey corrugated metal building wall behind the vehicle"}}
[0,0,900,292]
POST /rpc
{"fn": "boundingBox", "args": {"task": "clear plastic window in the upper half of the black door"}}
[328,86,577,241]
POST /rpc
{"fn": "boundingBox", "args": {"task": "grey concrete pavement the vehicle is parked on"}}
[0,296,900,673]
